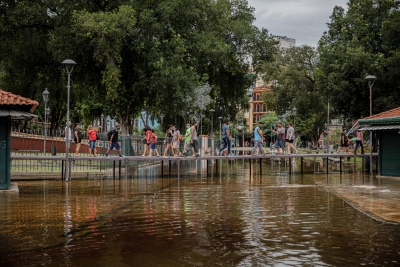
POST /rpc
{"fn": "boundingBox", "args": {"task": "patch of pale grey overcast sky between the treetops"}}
[247,0,348,47]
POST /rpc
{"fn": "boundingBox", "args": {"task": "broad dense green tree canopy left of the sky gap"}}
[0,0,275,133]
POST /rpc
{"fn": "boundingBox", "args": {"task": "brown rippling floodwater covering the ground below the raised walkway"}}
[0,160,400,267]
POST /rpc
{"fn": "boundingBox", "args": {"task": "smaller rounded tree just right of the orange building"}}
[263,45,327,142]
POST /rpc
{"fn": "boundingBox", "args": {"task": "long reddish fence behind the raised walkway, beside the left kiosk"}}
[11,129,219,173]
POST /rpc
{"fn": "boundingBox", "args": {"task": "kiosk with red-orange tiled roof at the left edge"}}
[0,89,39,190]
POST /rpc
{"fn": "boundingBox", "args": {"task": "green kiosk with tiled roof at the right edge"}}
[358,107,400,178]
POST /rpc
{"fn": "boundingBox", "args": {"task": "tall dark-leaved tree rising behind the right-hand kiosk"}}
[318,0,400,119]
